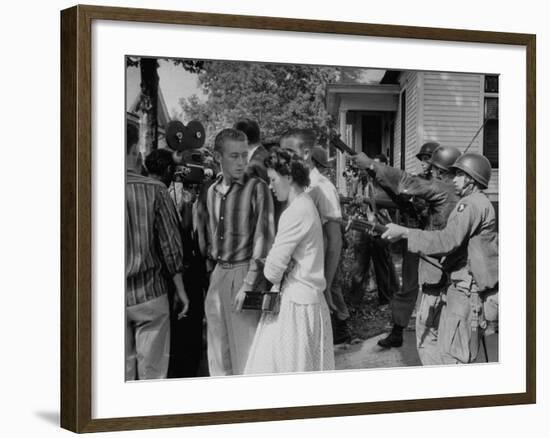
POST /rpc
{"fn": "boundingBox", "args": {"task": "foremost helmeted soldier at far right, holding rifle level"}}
[382,153,498,364]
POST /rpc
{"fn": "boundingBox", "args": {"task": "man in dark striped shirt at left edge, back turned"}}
[126,124,189,380]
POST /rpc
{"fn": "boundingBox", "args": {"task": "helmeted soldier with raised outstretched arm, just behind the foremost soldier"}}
[355,142,460,358]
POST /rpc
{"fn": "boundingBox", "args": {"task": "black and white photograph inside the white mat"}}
[125,55,499,381]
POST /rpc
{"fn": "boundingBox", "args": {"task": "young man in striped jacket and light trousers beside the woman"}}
[205,129,275,376]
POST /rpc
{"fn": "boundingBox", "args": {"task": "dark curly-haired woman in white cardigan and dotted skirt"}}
[245,148,334,374]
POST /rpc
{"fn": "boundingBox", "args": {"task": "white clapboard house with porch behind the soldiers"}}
[326,70,498,203]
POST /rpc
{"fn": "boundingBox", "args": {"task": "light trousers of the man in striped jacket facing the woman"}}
[204,263,260,376]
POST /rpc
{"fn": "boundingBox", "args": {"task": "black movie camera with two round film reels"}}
[166,120,215,186]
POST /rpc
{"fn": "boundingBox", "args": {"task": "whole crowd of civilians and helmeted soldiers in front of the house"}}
[126,119,498,380]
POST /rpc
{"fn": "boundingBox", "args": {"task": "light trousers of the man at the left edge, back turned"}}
[126,294,170,380]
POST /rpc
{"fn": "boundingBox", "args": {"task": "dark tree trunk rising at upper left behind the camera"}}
[140,58,159,153]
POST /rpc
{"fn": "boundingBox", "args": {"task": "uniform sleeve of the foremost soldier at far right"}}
[408,201,481,256]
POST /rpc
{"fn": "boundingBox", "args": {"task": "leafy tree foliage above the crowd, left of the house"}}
[180,61,342,144]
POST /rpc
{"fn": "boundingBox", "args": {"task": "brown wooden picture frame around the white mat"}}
[61,6,536,432]
